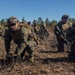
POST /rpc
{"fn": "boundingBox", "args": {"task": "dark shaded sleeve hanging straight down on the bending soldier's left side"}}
[5,30,12,54]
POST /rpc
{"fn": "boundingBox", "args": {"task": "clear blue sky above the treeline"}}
[0,0,75,22]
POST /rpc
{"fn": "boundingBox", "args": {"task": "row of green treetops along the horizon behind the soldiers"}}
[0,17,75,27]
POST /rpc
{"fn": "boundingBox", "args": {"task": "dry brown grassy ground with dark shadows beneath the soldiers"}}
[0,29,75,75]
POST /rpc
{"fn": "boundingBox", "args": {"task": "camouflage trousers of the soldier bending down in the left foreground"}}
[21,41,36,58]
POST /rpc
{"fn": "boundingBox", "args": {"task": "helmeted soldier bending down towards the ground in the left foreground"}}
[5,16,37,62]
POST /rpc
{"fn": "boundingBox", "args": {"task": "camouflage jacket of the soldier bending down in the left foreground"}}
[5,26,35,55]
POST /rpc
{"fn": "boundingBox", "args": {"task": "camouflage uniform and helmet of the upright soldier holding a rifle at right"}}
[54,15,69,52]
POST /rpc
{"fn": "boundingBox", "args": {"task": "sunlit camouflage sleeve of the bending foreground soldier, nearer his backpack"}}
[16,27,29,55]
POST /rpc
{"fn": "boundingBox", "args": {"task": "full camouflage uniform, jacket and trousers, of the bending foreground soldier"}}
[5,17,36,61]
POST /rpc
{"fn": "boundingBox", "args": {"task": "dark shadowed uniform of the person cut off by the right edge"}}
[67,24,75,59]
